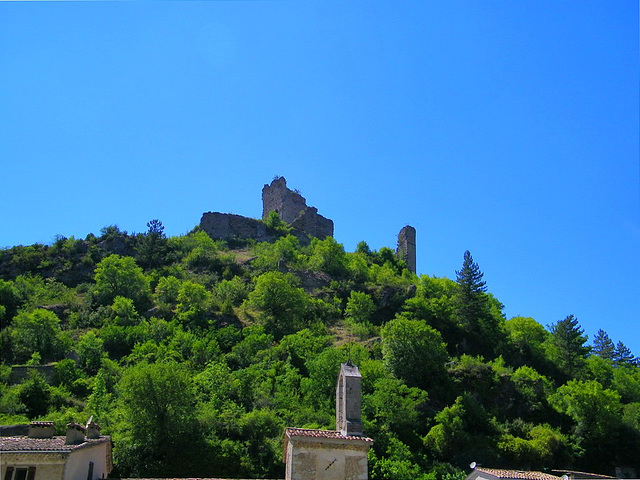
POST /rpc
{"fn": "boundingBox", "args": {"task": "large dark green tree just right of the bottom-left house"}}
[114,363,198,476]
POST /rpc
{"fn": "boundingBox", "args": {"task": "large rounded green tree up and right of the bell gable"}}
[380,317,448,390]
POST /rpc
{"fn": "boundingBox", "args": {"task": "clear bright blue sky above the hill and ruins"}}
[0,0,640,355]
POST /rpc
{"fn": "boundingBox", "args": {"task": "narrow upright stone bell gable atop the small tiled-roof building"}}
[336,362,362,437]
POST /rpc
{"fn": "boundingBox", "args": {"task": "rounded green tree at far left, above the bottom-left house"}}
[11,308,62,362]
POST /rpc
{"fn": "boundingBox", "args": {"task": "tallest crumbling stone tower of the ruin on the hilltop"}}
[262,177,333,238]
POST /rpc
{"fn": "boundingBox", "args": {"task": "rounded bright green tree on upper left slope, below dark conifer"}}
[93,254,150,310]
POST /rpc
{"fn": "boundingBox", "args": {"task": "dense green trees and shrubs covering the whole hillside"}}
[0,223,640,480]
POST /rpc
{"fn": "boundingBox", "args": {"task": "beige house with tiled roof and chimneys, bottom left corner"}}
[0,419,112,480]
